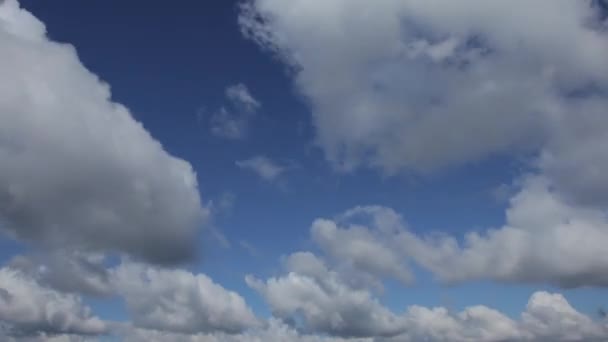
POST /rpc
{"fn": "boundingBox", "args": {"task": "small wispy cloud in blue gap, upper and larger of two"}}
[210,83,261,140]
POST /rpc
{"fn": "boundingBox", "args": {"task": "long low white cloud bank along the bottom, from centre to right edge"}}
[246,252,608,342]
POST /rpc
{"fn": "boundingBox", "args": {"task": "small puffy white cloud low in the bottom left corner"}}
[0,267,106,337]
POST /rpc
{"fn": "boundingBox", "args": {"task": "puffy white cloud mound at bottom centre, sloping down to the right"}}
[246,253,404,337]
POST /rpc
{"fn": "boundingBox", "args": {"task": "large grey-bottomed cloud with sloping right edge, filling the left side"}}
[0,0,207,263]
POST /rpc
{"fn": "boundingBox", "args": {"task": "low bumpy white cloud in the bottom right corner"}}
[395,292,608,342]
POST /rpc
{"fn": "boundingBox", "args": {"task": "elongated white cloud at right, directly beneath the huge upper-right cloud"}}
[311,198,608,287]
